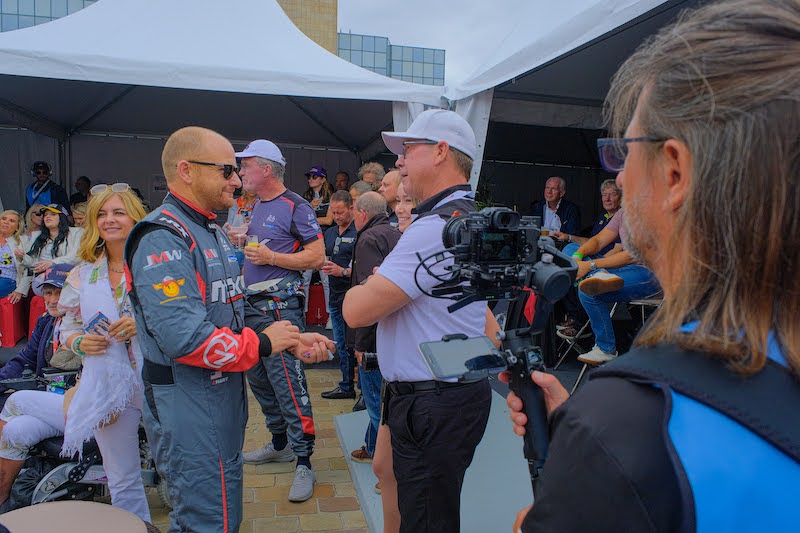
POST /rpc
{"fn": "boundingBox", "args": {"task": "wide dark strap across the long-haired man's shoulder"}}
[589,345,800,462]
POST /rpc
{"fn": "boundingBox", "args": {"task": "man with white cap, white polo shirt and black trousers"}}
[344,109,496,532]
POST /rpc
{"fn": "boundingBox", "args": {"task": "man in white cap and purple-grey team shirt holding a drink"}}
[236,139,325,502]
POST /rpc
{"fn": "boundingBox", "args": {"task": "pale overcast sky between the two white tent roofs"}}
[339,0,531,84]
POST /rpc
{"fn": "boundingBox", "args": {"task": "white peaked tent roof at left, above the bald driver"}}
[0,0,441,105]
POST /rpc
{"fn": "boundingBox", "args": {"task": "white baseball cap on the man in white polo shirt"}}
[381,109,478,159]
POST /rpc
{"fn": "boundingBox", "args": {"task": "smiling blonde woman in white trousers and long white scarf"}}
[59,183,150,522]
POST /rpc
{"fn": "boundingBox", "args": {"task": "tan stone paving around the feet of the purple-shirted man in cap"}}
[148,368,368,533]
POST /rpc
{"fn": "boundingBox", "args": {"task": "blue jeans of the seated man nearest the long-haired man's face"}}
[578,265,661,353]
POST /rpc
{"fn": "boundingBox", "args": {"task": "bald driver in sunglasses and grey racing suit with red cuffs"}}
[126,127,332,533]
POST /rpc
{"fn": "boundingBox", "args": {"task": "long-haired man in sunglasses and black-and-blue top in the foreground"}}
[508,0,800,533]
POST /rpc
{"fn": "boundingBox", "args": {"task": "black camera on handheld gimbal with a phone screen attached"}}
[419,207,578,494]
